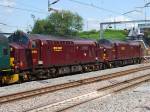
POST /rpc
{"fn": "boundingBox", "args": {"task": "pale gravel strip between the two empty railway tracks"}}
[0,64,150,112]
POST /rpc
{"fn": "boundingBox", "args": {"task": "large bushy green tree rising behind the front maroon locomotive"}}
[32,11,83,36]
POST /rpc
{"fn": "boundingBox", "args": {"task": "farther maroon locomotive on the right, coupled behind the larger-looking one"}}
[98,39,143,67]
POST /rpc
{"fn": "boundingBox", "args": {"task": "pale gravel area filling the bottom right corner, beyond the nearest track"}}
[63,81,150,112]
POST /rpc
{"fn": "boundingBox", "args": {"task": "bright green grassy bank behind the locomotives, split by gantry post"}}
[79,30,127,40]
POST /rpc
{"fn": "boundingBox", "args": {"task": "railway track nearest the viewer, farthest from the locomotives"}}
[28,74,150,112]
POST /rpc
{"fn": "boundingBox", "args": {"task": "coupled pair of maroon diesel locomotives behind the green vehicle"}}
[9,32,143,81]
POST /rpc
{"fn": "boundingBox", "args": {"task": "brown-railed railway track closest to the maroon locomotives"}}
[0,66,150,104]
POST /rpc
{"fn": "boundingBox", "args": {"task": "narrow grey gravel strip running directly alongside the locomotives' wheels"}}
[0,63,150,96]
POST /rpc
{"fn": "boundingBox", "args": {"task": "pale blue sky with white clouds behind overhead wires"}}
[0,0,150,33]
